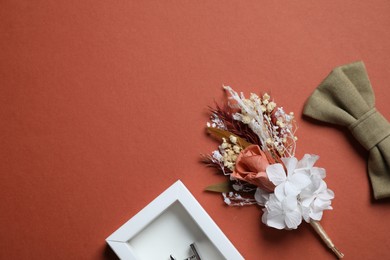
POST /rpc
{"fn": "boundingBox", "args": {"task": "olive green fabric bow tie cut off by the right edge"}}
[303,61,390,199]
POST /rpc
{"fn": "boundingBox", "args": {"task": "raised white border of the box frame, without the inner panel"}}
[106,180,244,260]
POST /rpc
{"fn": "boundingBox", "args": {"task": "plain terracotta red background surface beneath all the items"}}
[0,0,390,259]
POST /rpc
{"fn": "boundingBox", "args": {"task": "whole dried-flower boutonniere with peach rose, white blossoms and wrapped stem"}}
[203,86,343,258]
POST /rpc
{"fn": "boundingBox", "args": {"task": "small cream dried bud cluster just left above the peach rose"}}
[219,135,242,171]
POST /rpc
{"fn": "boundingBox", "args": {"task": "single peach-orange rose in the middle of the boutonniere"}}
[231,145,275,192]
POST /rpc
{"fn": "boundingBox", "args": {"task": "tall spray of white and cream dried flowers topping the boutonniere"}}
[224,86,297,156]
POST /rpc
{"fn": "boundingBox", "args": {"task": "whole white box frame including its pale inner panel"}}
[106,180,244,260]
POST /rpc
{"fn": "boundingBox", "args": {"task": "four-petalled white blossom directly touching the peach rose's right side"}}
[266,157,310,201]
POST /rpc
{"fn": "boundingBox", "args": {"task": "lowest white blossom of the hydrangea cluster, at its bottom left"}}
[262,194,302,229]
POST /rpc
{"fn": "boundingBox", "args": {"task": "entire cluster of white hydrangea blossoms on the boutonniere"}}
[262,154,334,229]
